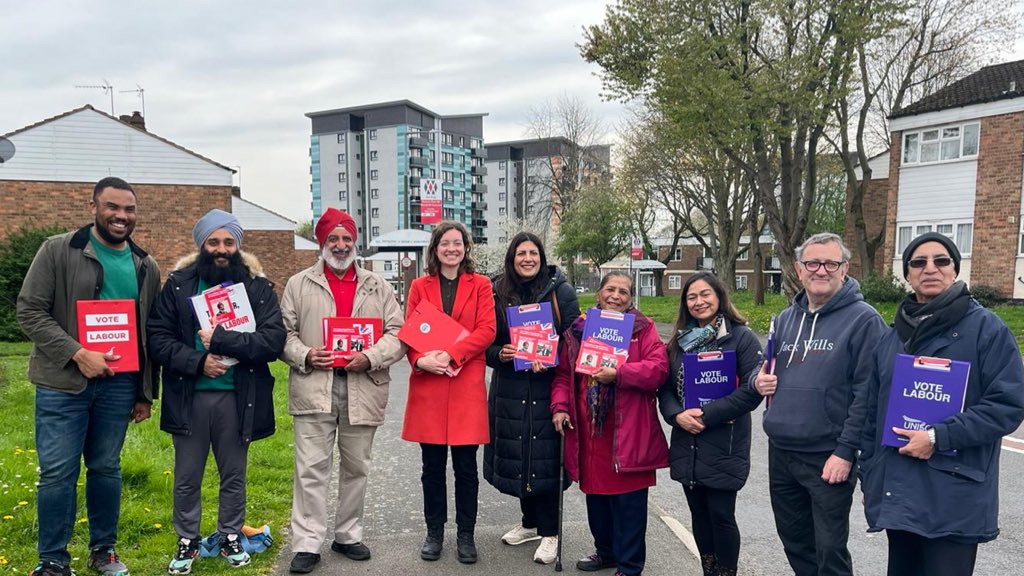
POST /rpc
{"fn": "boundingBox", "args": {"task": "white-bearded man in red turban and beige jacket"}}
[281,208,406,573]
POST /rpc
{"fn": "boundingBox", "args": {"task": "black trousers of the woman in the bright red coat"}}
[420,444,480,532]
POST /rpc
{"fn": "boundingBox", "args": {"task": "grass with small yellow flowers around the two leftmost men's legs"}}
[0,354,293,575]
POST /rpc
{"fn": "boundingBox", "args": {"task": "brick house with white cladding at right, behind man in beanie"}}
[883,60,1024,299]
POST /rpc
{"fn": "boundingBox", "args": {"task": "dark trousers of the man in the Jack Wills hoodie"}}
[768,444,857,576]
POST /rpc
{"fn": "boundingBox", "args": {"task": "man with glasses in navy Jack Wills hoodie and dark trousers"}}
[754,233,886,576]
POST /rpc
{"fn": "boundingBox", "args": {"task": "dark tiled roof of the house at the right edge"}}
[890,60,1024,118]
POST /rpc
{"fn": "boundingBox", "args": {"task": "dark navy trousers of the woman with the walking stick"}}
[587,488,648,576]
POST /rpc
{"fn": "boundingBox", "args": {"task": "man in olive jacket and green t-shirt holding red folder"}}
[17,177,160,576]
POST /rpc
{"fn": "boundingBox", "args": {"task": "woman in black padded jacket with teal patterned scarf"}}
[658,273,761,576]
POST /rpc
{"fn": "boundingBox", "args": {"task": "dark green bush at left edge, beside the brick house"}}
[0,227,65,342]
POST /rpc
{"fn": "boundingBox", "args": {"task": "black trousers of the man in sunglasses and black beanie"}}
[886,530,978,576]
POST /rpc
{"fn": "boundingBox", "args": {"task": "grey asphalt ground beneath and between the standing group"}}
[276,325,1024,576]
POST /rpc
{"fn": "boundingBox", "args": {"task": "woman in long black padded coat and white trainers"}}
[483,232,580,564]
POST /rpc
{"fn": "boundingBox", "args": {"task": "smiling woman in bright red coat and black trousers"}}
[401,220,495,564]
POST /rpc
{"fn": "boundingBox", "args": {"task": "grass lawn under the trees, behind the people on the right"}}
[577,291,1024,354]
